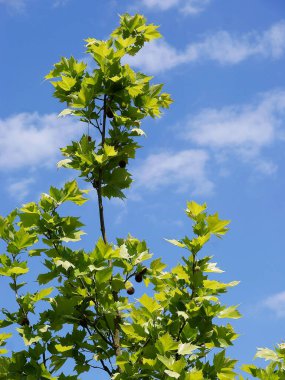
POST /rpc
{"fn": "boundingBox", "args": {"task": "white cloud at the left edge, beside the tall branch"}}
[0,112,82,170]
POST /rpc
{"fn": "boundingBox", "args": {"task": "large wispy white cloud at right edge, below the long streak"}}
[182,90,285,174]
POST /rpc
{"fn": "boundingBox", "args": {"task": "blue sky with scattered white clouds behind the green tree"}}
[0,0,285,378]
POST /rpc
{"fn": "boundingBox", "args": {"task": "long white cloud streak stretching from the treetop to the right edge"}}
[125,21,285,73]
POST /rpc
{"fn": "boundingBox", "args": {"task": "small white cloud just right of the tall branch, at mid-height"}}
[134,149,213,195]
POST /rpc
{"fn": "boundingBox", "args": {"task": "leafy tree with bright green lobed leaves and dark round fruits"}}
[0,14,285,380]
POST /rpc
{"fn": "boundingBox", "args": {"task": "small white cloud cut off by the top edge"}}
[142,0,211,14]
